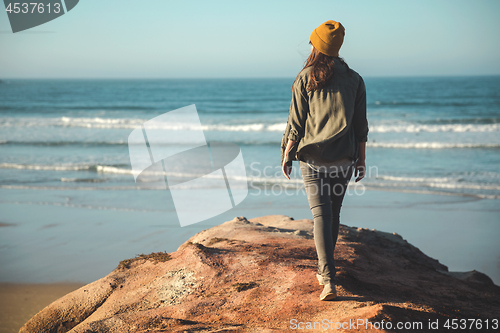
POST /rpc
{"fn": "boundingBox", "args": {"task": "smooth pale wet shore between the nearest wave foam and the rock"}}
[0,189,500,284]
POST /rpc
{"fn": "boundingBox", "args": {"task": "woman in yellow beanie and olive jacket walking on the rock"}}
[281,20,368,301]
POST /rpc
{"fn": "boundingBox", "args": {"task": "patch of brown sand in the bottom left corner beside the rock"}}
[0,283,84,333]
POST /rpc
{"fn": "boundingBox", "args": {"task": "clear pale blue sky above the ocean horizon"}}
[0,0,500,78]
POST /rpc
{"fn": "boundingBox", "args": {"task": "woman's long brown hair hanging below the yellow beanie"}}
[297,42,349,91]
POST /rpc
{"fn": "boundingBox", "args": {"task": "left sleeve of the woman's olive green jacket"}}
[288,78,309,142]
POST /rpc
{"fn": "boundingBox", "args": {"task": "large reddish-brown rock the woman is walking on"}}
[20,215,500,333]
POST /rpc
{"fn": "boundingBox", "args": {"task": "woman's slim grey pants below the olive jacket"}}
[300,162,354,283]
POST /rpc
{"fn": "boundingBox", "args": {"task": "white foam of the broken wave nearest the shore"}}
[0,164,500,199]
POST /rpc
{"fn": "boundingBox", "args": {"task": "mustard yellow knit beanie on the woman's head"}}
[310,20,345,57]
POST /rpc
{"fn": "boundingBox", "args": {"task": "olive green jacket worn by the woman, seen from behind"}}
[281,59,368,165]
